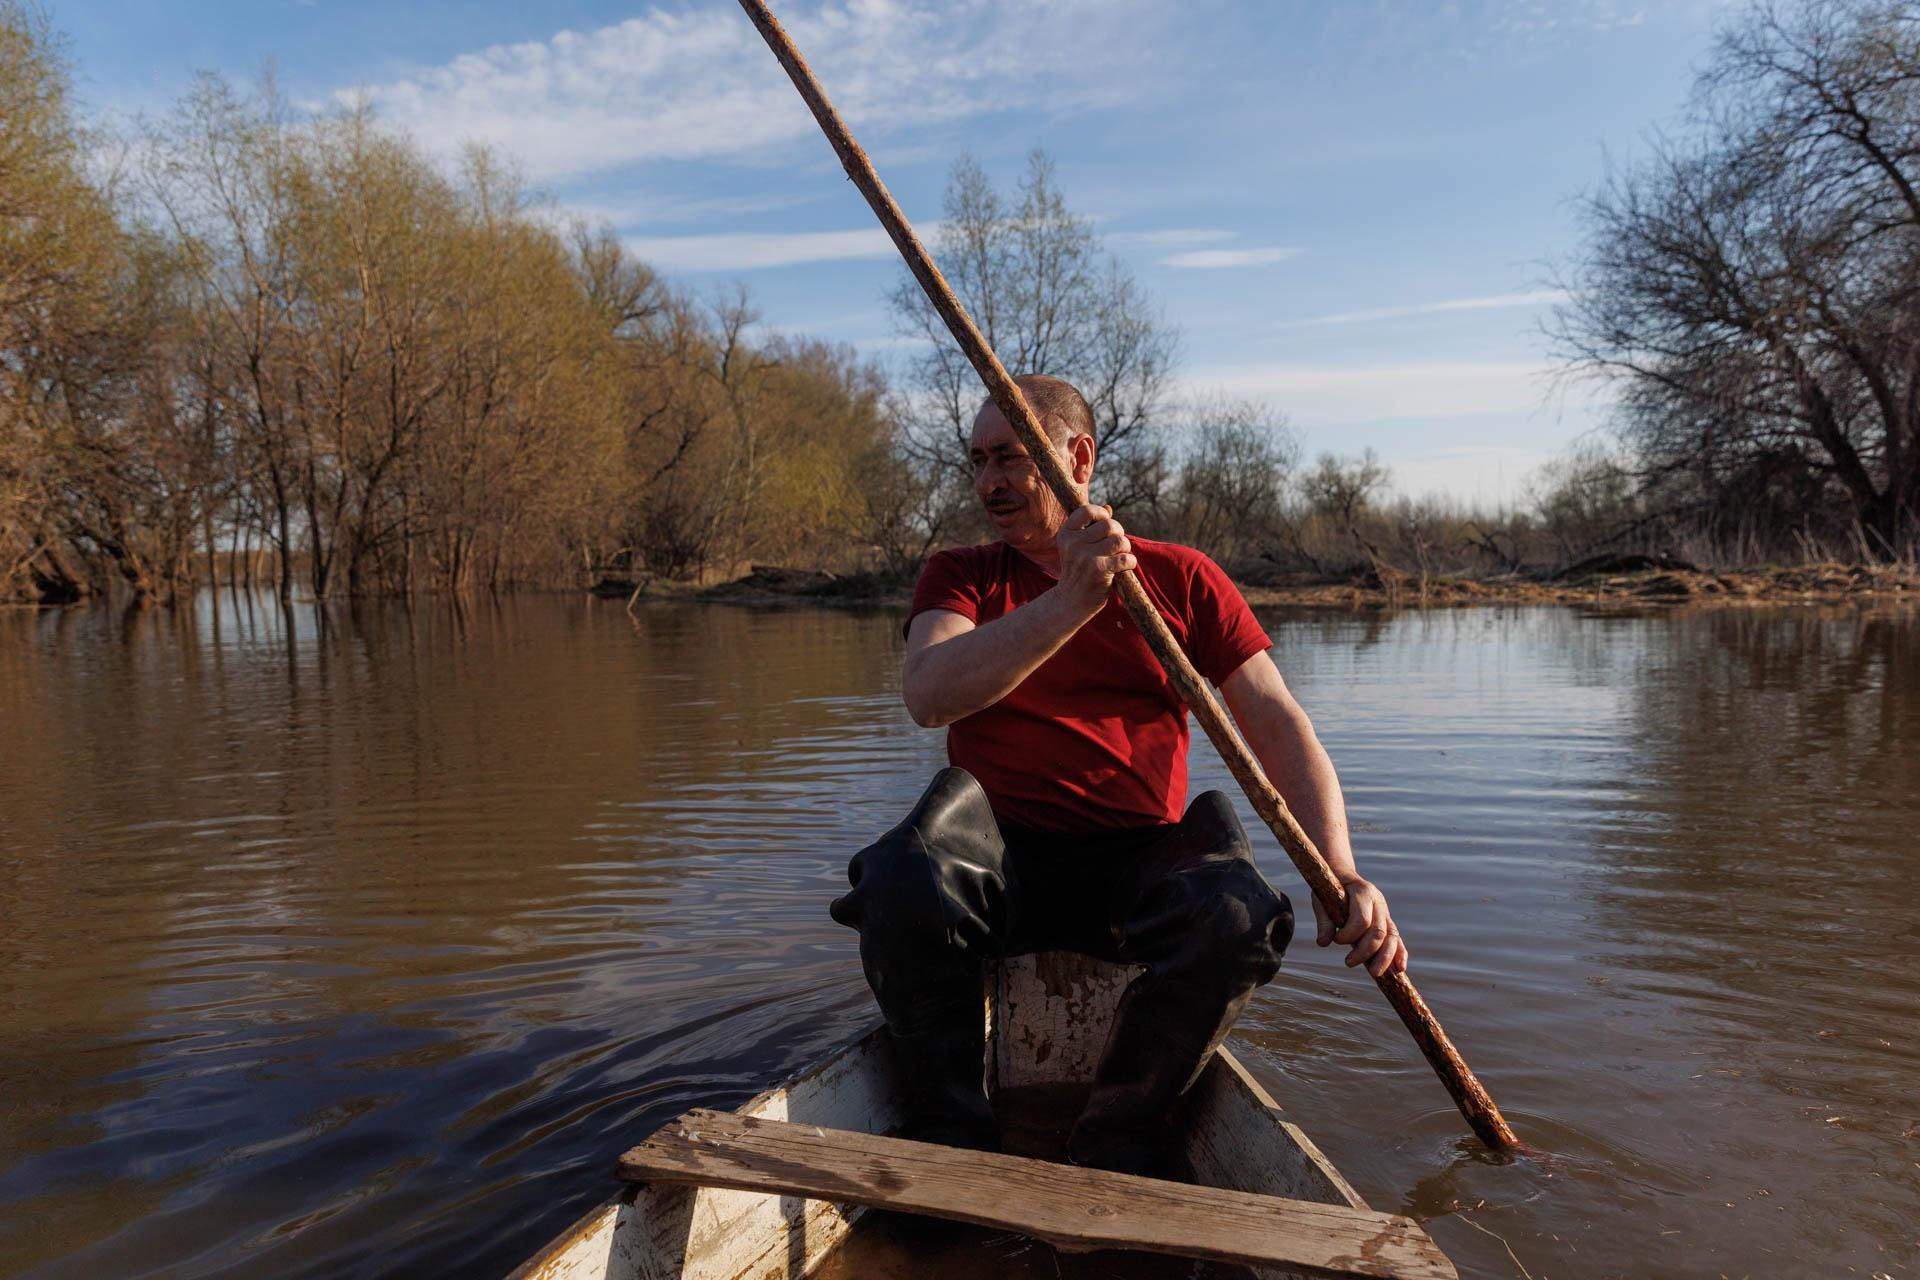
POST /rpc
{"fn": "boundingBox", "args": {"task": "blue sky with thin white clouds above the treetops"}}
[52,0,1724,499]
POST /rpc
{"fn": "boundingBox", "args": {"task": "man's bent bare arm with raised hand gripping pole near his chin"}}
[900,507,1135,729]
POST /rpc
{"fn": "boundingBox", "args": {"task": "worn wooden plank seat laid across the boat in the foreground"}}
[618,1109,1455,1280]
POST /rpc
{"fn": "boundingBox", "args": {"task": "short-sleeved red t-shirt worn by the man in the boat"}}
[908,535,1273,831]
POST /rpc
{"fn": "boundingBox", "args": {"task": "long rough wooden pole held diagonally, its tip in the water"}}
[739,0,1521,1151]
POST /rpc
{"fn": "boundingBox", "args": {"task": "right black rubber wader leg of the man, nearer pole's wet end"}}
[1068,791,1294,1180]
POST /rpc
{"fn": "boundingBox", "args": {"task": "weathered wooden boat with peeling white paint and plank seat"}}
[511,952,1455,1280]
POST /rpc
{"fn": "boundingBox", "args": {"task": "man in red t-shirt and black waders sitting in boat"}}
[833,374,1407,1173]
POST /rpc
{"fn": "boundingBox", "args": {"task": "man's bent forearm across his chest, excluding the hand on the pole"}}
[900,589,1092,729]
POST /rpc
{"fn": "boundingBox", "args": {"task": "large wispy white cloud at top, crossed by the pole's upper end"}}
[338,0,1179,180]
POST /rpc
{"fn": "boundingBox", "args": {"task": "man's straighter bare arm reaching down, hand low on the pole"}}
[1219,652,1407,975]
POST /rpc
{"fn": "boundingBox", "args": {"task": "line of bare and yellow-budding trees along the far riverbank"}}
[0,0,1920,603]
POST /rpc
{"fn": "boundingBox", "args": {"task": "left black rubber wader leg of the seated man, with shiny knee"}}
[829,770,1006,1151]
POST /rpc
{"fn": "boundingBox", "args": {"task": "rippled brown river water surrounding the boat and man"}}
[0,595,1920,1280]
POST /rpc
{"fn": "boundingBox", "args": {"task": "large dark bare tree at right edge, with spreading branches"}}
[1555,0,1920,555]
